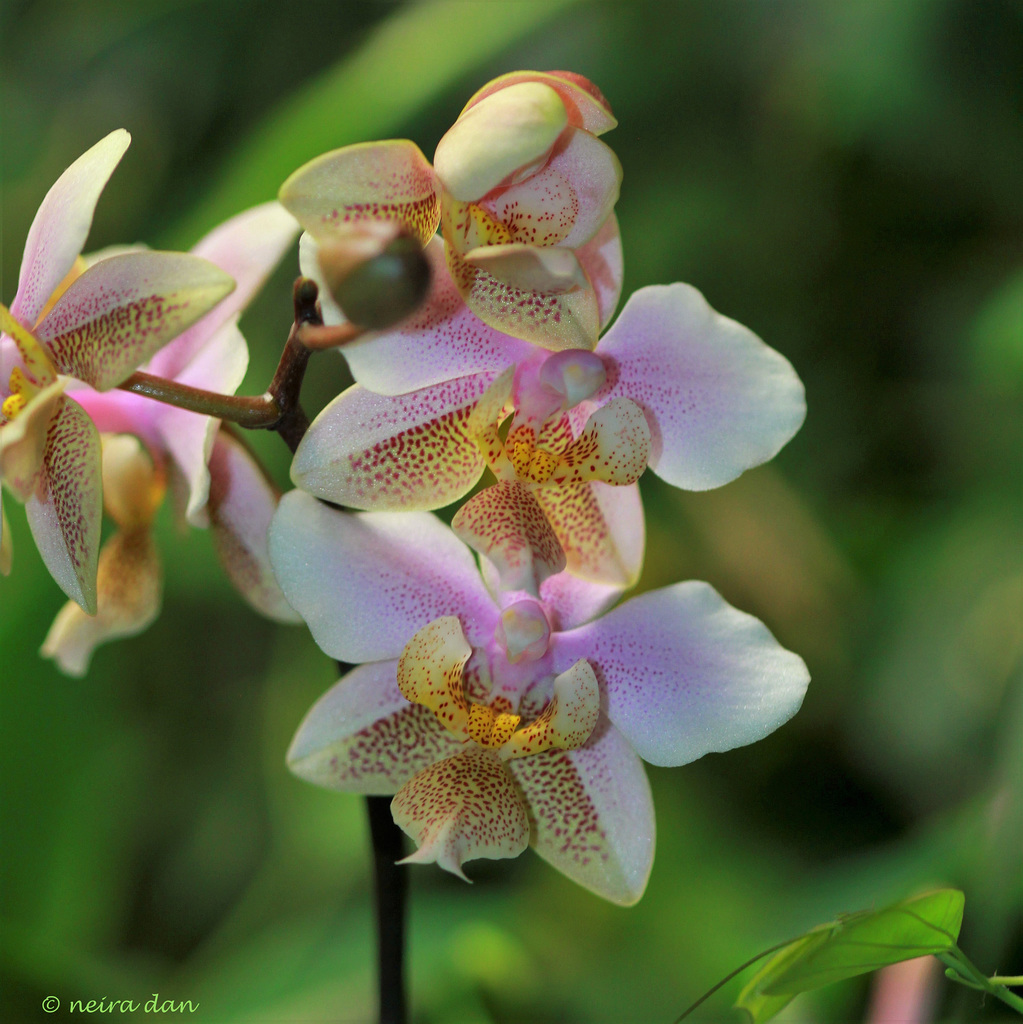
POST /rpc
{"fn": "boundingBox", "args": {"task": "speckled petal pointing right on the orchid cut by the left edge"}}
[38,252,235,391]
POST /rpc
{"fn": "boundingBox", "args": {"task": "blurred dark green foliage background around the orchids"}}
[0,0,1023,1024]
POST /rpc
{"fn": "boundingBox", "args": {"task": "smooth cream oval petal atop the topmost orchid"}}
[433,82,568,202]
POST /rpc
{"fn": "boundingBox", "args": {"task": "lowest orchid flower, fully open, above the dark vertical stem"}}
[270,492,808,904]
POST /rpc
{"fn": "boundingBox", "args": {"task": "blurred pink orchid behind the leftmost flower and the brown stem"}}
[43,203,298,675]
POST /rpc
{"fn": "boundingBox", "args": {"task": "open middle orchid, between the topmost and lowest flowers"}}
[292,258,806,594]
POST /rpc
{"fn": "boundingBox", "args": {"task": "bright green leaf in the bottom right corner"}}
[735,889,964,1024]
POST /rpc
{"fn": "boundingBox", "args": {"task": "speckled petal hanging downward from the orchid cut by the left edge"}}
[25,395,102,615]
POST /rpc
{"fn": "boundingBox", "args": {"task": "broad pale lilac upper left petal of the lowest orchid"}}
[270,490,498,663]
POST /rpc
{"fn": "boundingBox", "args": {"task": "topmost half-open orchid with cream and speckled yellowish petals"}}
[280,72,622,349]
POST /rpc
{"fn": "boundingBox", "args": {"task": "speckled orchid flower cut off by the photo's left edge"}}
[0,130,235,613]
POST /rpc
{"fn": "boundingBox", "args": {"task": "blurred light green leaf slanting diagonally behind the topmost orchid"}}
[166,0,578,247]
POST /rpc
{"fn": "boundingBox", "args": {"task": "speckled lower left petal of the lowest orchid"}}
[288,662,462,797]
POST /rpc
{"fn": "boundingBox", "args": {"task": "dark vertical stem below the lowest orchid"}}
[366,797,409,1024]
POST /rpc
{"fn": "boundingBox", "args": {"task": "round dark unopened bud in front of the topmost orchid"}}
[317,229,430,331]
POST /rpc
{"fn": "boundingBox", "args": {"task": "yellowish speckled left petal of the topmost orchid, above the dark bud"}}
[279,139,440,246]
